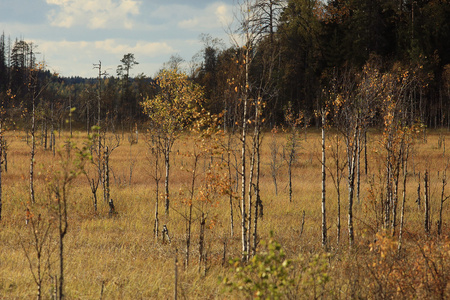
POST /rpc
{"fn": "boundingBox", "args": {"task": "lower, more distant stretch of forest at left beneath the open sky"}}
[0,33,155,131]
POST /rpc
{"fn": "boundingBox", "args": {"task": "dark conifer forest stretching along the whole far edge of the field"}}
[0,0,450,129]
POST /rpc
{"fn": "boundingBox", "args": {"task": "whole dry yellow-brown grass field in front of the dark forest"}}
[0,129,450,299]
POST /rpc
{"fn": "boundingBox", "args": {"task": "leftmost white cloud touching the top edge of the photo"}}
[46,0,141,29]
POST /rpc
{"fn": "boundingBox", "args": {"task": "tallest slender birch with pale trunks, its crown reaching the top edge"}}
[229,0,283,259]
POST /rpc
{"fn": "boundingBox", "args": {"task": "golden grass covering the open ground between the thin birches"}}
[0,130,450,299]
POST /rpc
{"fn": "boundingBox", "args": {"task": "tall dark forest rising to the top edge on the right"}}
[194,0,450,127]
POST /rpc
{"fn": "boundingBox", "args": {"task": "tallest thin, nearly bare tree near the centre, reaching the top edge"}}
[229,0,281,260]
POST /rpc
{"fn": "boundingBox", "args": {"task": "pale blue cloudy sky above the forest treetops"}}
[0,0,234,77]
